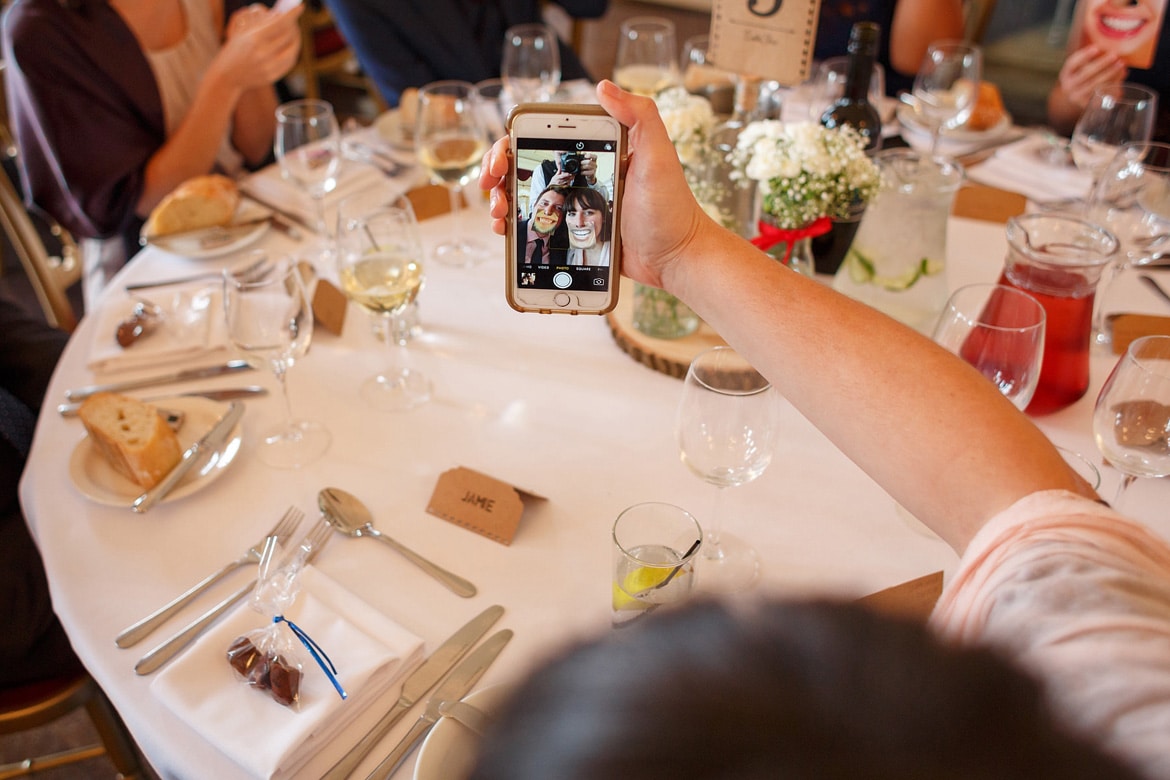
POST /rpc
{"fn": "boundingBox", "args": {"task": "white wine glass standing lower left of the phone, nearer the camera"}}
[337,188,431,412]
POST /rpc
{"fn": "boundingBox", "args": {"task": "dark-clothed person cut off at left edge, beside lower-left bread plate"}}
[0,298,82,686]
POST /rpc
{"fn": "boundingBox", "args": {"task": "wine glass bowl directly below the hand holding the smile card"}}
[1069,83,1158,192]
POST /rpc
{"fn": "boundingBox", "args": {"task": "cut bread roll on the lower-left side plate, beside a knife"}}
[78,393,183,490]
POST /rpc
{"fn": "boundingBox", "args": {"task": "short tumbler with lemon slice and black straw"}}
[612,502,703,627]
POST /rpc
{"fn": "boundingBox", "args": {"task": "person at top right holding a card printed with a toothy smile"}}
[1048,0,1170,140]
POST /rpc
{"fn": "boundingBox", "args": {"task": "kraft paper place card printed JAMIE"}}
[427,467,544,545]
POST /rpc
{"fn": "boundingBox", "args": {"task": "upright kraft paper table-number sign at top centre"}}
[710,0,820,87]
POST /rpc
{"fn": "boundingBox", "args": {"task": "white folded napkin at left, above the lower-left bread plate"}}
[87,285,232,374]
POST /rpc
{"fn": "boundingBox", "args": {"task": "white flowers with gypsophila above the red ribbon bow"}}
[731,119,881,229]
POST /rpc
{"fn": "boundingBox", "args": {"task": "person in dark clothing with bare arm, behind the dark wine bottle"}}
[813,0,963,95]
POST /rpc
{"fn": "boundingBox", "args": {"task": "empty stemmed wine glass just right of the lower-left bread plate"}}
[223,258,332,469]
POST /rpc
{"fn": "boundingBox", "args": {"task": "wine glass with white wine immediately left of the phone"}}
[414,81,488,267]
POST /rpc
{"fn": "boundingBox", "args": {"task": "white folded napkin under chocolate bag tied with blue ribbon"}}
[150,566,422,778]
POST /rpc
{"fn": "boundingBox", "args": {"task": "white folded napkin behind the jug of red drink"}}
[966,134,1093,201]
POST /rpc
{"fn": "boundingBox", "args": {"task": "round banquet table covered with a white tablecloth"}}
[21,190,1170,780]
